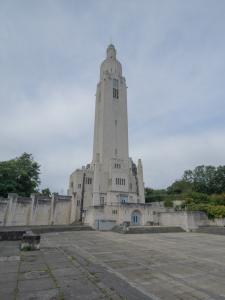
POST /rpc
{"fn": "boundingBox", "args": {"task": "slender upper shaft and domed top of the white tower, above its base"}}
[93,45,128,166]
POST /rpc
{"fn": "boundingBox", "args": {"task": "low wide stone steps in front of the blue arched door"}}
[112,225,185,234]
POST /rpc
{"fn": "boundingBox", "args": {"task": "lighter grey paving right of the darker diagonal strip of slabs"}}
[40,232,225,300]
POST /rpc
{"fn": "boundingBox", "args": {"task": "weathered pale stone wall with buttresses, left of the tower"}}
[0,194,74,226]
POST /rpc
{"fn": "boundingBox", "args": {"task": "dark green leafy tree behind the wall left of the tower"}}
[0,153,40,197]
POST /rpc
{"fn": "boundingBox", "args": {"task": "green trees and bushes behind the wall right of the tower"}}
[145,165,225,218]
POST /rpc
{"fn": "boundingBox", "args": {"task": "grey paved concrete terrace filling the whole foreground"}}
[0,231,225,300]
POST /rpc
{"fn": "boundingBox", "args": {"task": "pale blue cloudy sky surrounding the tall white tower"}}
[0,0,225,193]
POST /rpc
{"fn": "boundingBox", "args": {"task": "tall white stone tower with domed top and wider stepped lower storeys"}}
[69,45,145,226]
